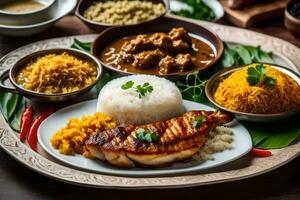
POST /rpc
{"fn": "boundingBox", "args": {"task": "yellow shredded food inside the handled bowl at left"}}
[16,53,97,94]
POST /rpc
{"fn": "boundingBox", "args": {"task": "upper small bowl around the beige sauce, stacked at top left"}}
[0,0,57,26]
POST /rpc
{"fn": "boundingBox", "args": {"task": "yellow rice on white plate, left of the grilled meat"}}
[50,112,117,158]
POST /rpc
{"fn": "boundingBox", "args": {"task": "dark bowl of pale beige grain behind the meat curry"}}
[75,0,168,31]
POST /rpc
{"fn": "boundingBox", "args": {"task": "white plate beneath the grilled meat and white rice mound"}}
[38,100,252,176]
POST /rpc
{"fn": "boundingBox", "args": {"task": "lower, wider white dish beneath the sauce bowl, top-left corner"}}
[0,0,77,36]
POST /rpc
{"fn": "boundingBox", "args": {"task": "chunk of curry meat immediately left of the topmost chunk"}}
[149,33,172,50]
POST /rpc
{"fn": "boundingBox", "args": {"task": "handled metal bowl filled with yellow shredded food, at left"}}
[0,49,102,102]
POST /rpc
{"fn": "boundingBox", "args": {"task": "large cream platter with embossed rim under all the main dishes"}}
[0,17,300,189]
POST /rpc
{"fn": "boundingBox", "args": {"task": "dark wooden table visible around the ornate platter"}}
[0,16,300,200]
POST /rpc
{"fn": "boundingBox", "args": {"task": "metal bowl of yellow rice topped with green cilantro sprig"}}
[205,63,300,122]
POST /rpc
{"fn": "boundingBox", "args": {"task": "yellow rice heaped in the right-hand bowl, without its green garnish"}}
[214,64,300,114]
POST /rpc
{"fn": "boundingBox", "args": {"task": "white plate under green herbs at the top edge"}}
[170,0,224,21]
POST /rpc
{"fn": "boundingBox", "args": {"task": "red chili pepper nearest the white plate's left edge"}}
[27,107,54,151]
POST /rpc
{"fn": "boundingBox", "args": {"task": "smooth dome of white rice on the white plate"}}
[97,75,184,125]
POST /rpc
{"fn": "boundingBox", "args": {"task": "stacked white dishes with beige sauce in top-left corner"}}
[0,0,77,36]
